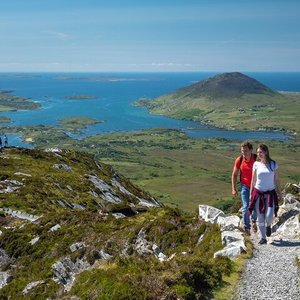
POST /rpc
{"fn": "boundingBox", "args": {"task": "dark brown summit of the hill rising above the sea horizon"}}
[182,72,276,98]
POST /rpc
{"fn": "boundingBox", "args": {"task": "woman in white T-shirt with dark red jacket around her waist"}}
[249,144,281,244]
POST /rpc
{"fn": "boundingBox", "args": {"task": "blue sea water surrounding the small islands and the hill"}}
[0,72,300,147]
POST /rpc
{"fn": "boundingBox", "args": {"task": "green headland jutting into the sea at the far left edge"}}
[0,91,40,111]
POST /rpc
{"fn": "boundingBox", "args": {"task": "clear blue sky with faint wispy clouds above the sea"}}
[0,0,300,72]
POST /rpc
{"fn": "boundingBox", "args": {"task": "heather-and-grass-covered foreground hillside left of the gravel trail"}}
[0,148,233,299]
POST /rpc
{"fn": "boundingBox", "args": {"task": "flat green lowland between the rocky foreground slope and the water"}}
[14,127,300,212]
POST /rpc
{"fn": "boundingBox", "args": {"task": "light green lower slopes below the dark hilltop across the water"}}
[140,93,300,134]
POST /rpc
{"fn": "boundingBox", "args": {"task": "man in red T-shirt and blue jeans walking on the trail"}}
[231,141,257,235]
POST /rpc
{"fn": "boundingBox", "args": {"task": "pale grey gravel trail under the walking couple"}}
[237,234,300,300]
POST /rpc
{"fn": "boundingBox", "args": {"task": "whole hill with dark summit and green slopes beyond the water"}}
[136,73,300,134]
